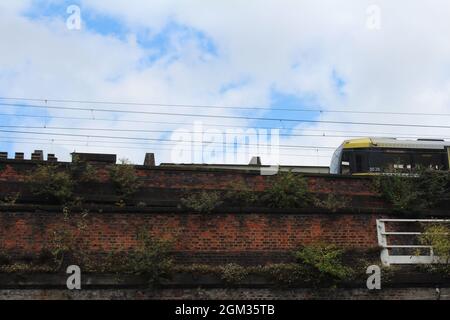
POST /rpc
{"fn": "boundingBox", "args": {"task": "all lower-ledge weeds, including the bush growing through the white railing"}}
[6,238,450,288]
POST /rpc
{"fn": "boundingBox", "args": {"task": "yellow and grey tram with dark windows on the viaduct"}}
[330,138,450,175]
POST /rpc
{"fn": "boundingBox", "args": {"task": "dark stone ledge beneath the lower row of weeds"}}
[0,273,450,290]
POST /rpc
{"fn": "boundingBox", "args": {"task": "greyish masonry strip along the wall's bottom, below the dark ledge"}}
[0,287,450,301]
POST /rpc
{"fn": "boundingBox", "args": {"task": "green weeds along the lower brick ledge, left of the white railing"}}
[0,241,360,287]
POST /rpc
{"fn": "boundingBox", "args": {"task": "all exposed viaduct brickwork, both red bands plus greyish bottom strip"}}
[0,161,449,299]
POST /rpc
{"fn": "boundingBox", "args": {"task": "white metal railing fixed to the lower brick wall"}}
[377,219,450,266]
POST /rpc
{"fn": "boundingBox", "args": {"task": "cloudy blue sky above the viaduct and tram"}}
[0,0,450,166]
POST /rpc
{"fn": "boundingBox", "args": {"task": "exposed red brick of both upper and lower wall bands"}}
[0,161,379,262]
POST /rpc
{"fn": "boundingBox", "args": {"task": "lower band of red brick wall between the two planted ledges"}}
[0,212,377,262]
